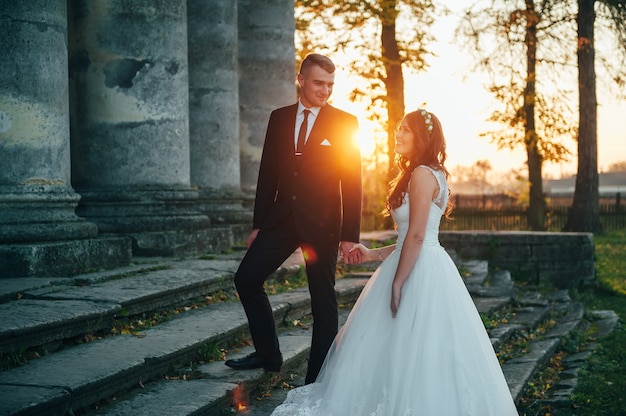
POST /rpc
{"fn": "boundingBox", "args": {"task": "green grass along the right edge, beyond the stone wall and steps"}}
[573,231,626,416]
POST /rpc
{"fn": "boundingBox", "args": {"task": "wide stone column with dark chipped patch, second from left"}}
[69,0,232,255]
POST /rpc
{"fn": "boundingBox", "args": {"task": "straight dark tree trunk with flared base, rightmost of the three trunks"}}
[564,0,602,232]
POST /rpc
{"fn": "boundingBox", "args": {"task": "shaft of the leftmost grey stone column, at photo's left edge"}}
[0,0,71,188]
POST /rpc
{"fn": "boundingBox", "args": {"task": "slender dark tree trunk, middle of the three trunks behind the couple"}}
[523,0,546,231]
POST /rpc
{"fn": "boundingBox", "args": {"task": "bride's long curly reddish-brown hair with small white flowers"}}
[385,109,454,219]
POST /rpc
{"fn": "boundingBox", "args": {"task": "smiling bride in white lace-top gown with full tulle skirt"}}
[272,109,518,416]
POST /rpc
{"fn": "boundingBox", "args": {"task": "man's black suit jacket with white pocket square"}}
[253,104,361,242]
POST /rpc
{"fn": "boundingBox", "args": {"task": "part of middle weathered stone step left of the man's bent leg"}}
[0,303,247,409]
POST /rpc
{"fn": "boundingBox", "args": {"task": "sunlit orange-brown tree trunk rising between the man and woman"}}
[381,1,404,178]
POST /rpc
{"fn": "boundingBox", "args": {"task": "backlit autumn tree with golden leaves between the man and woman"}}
[296,0,435,179]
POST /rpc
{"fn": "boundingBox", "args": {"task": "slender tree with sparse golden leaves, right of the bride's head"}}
[458,0,575,230]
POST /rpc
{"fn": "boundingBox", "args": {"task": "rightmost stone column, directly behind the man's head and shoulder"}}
[237,0,297,193]
